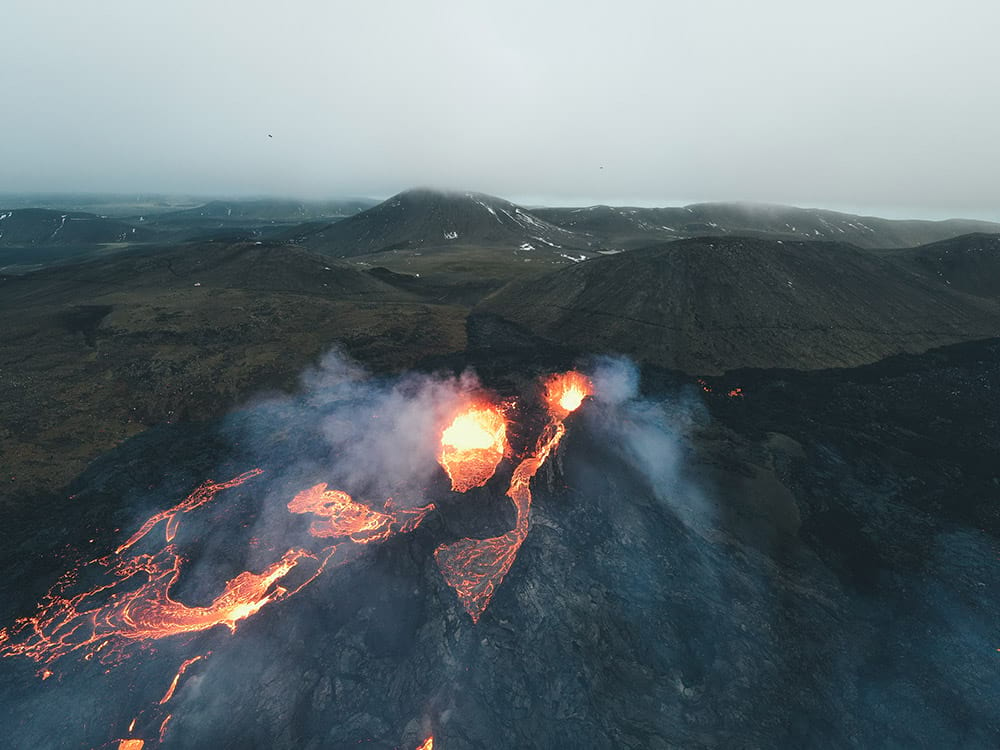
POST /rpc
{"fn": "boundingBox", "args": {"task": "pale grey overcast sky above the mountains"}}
[0,0,1000,219]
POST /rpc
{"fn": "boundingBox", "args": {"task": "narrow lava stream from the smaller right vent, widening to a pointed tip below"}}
[434,372,592,622]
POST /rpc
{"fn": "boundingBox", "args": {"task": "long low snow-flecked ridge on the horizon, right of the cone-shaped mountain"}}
[534,203,1000,249]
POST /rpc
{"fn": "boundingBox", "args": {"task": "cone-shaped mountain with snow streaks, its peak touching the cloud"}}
[291,189,587,257]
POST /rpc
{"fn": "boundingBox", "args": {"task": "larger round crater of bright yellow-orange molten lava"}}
[438,403,507,492]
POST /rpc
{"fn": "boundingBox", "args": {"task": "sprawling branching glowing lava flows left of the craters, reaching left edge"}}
[0,469,434,668]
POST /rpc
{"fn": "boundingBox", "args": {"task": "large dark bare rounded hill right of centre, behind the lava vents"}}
[477,238,1000,373]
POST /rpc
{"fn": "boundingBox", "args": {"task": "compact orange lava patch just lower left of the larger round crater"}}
[288,483,434,544]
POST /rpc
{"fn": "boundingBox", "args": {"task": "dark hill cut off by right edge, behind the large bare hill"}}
[887,234,1000,298]
